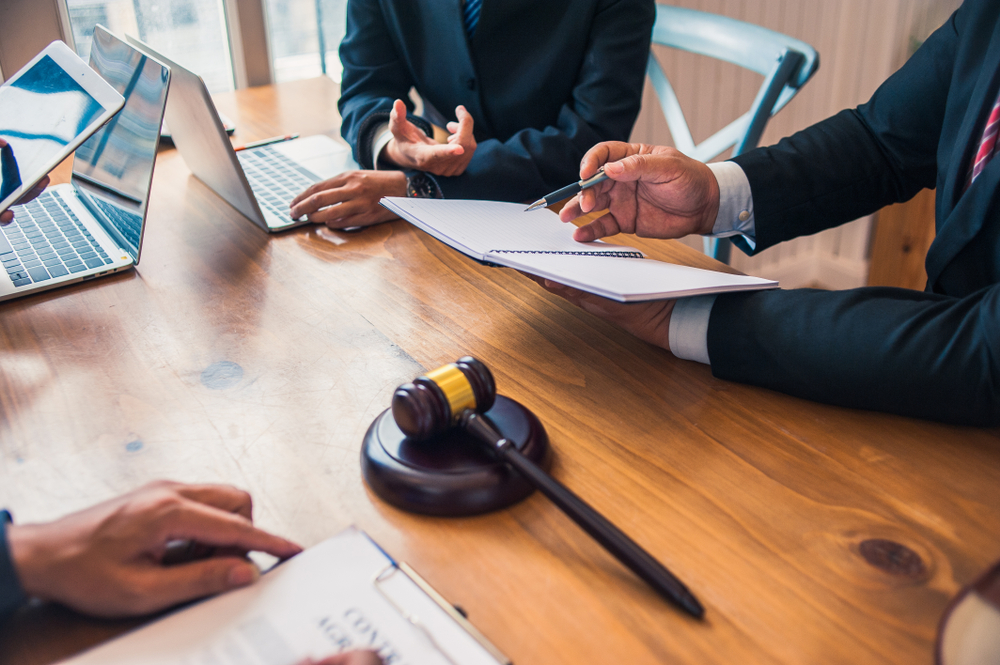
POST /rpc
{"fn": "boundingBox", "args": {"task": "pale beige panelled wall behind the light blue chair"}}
[632,0,961,288]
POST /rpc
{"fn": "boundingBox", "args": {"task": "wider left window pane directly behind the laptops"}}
[66,0,234,92]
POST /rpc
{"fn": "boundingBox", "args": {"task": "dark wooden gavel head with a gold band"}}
[392,356,497,441]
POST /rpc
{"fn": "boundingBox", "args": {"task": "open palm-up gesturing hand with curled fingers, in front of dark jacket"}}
[382,99,476,176]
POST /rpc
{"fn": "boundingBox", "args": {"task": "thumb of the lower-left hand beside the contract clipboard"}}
[136,557,260,612]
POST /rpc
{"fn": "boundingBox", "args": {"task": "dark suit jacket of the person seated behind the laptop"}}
[339,0,654,201]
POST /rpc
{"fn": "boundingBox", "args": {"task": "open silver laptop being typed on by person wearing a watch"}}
[127,37,360,232]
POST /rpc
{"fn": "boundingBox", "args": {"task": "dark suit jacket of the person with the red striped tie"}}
[708,0,1000,425]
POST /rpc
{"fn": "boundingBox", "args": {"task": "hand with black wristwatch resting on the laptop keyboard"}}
[291,171,406,229]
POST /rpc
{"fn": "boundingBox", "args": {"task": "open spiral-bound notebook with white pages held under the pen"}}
[381,197,778,302]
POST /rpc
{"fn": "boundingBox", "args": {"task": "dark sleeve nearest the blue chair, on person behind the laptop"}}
[437,0,655,201]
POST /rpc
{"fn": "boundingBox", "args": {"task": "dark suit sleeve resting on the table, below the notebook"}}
[708,285,1000,426]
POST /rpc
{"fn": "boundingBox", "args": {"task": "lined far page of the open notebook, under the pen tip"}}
[382,197,638,260]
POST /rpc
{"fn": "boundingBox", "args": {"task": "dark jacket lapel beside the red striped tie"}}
[925,17,1000,285]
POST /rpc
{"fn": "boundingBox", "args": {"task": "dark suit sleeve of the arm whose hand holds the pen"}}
[733,10,961,254]
